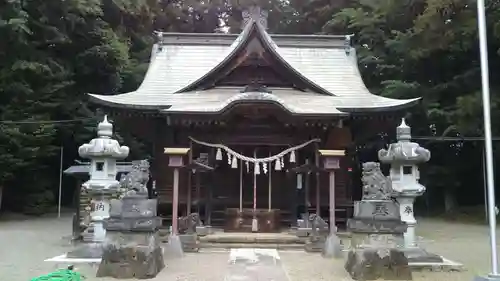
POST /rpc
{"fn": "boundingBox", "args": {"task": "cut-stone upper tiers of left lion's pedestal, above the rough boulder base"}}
[105,195,161,232]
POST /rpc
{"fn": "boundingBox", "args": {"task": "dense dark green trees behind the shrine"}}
[0,0,500,213]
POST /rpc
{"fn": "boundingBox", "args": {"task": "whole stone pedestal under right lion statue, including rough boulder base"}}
[345,200,413,280]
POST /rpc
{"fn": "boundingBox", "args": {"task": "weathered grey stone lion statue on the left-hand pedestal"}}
[120,160,149,194]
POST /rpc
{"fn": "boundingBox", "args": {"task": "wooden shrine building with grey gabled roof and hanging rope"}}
[90,7,419,231]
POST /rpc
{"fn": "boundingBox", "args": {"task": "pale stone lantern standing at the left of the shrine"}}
[78,116,129,242]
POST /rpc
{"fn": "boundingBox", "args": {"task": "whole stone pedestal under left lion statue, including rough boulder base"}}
[97,194,165,279]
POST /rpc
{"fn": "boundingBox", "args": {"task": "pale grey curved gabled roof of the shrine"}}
[90,18,418,115]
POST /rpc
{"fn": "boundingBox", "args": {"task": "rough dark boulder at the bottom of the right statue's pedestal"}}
[345,248,413,281]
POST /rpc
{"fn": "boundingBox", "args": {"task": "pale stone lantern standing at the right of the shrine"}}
[378,118,442,262]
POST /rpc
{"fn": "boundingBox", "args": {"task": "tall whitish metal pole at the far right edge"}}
[477,0,498,276]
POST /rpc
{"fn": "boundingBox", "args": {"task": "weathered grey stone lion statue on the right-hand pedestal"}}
[361,162,392,200]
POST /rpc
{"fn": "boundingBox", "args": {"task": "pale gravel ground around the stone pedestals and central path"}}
[0,213,496,281]
